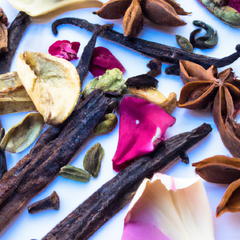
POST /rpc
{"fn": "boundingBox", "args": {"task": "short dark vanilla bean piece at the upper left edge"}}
[0,12,31,74]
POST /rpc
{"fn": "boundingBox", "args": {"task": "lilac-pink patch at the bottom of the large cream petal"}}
[122,222,170,240]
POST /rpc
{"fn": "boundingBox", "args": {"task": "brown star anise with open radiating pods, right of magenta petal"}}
[178,60,240,157]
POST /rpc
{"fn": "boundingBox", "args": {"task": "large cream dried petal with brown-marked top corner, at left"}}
[17,51,80,125]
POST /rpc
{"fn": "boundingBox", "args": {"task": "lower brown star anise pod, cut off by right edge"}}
[216,179,240,217]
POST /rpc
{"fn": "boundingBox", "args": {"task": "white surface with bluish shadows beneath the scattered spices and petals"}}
[0,0,240,240]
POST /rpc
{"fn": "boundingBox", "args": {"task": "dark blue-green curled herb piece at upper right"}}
[190,20,218,49]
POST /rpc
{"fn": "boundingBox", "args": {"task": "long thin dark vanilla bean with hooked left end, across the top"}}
[52,18,240,73]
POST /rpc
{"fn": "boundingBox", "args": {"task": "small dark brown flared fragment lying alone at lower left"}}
[28,191,60,214]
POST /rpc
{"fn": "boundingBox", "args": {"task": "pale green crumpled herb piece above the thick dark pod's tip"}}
[82,68,126,98]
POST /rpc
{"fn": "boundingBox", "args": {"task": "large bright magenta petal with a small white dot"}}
[112,97,176,171]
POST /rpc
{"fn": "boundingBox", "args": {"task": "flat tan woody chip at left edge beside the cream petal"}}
[0,72,36,115]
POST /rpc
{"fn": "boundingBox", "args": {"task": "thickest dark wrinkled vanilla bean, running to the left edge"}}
[0,90,109,231]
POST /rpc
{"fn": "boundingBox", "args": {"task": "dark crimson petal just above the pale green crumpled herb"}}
[89,47,126,77]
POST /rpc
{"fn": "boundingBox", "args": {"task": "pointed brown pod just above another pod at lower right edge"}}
[193,155,240,184]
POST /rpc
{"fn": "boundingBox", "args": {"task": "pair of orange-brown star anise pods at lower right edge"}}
[193,155,240,217]
